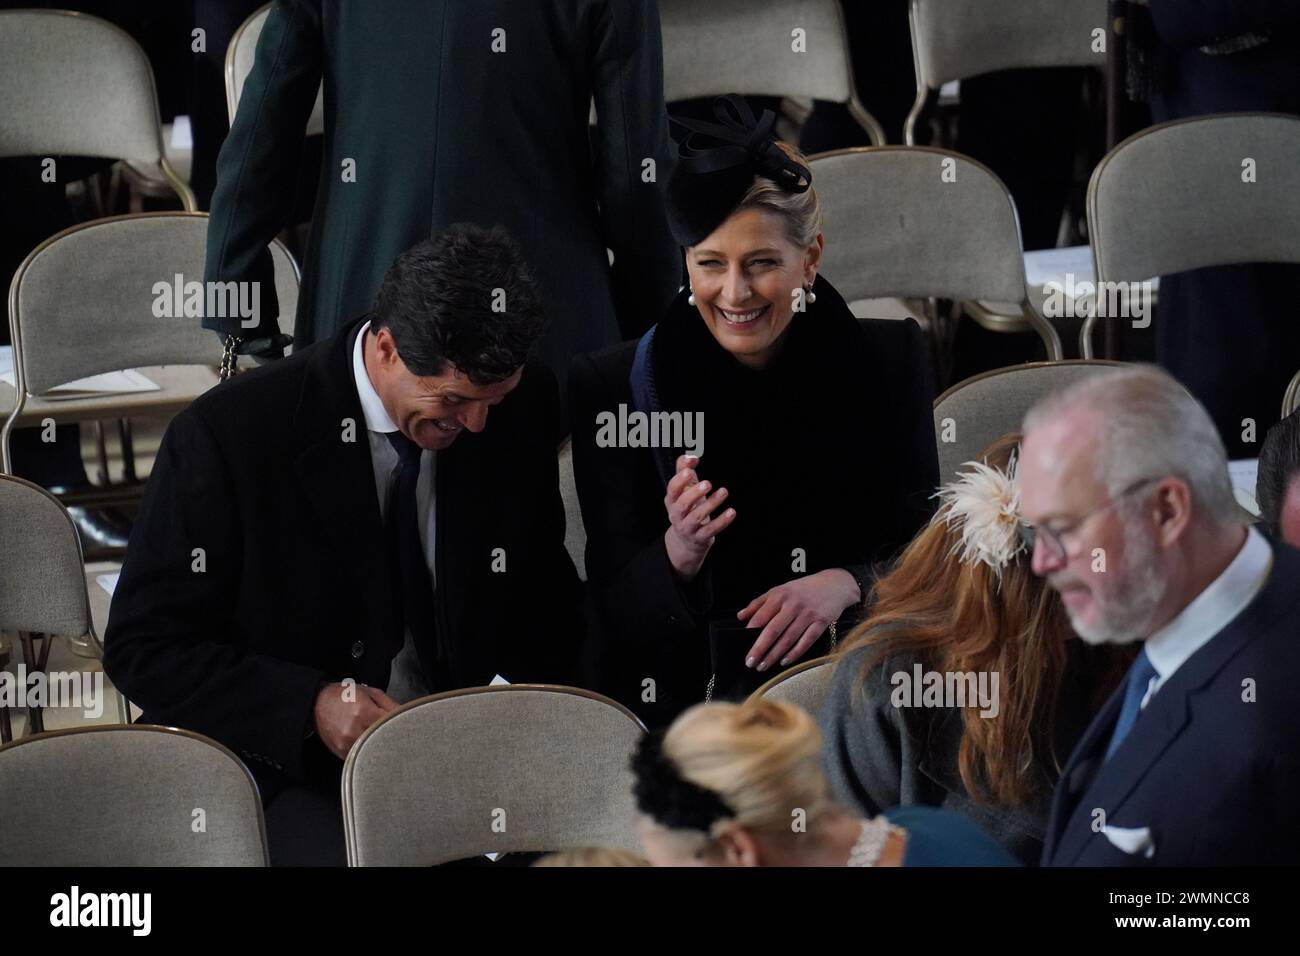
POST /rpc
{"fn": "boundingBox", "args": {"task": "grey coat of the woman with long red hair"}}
[819,648,1087,866]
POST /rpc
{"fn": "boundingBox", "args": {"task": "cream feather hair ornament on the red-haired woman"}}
[932,454,1024,584]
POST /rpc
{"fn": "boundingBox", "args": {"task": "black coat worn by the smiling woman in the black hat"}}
[569,277,939,724]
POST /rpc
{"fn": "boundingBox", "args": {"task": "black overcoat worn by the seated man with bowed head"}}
[104,323,580,799]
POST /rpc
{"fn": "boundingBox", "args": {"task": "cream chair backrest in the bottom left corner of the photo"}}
[0,726,268,866]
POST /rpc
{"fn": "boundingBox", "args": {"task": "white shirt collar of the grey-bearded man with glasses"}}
[1147,527,1273,683]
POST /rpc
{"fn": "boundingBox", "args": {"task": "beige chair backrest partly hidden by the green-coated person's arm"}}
[9,212,298,398]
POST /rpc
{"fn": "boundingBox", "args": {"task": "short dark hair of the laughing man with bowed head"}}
[371,222,547,385]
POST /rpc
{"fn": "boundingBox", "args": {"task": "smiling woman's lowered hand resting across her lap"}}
[736,567,862,671]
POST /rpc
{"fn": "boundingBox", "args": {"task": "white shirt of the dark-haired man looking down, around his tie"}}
[352,323,438,704]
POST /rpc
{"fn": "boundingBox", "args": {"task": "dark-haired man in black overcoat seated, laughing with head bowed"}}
[104,226,580,864]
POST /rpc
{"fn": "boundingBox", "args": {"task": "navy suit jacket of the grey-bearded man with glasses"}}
[1043,541,1300,866]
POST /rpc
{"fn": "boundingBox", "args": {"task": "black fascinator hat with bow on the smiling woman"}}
[667,94,813,246]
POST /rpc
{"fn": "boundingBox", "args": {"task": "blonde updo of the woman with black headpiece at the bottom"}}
[663,700,831,834]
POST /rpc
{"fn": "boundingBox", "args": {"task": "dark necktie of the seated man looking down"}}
[385,432,443,680]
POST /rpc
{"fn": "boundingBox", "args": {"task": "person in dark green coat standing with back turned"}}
[204,0,681,408]
